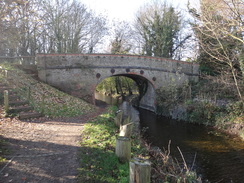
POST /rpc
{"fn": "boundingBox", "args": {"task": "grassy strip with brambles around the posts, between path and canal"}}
[79,107,201,183]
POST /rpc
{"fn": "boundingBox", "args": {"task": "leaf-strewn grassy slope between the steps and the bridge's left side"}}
[0,63,95,117]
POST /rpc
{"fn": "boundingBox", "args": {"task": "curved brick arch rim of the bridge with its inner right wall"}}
[93,73,156,112]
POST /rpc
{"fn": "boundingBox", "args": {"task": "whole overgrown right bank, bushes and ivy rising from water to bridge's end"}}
[156,77,244,139]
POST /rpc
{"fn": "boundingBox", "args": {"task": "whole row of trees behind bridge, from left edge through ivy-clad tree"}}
[0,0,189,58]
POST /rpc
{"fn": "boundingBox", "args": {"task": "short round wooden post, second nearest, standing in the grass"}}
[115,136,131,163]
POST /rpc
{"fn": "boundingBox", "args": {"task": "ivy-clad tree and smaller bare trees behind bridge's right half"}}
[107,0,191,59]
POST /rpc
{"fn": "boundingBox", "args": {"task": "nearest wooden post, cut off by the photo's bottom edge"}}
[130,158,151,183]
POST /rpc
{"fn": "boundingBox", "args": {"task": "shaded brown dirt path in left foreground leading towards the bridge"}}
[0,109,104,183]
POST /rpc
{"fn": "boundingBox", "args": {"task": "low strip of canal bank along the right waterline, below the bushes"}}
[156,99,244,141]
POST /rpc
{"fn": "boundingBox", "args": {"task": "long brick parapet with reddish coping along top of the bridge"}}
[37,54,199,76]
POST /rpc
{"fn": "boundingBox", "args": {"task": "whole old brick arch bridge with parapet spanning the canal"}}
[37,54,199,112]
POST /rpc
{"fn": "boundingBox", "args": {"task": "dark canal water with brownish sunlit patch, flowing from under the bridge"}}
[95,93,244,183]
